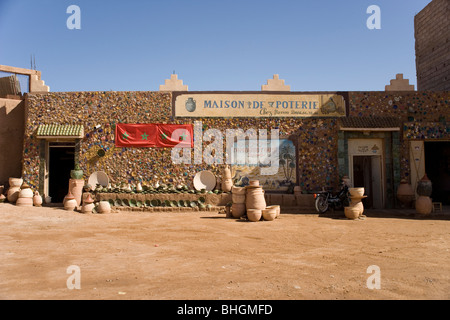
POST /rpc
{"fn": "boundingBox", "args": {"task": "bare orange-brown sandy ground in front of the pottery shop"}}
[0,204,450,300]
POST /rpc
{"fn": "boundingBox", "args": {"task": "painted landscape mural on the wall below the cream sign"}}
[231,139,297,191]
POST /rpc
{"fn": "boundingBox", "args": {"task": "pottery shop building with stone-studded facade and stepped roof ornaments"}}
[23,75,450,208]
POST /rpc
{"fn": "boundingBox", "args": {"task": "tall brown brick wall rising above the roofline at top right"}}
[414,0,450,90]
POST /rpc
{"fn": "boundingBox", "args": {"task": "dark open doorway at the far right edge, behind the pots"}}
[425,141,450,205]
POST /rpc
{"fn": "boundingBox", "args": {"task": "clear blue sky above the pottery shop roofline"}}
[0,0,430,91]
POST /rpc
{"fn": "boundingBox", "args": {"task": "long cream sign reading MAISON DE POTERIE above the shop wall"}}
[175,93,345,118]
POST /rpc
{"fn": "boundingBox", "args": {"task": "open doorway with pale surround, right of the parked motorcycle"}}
[353,156,384,209]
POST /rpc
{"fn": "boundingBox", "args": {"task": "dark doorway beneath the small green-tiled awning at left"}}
[48,145,75,203]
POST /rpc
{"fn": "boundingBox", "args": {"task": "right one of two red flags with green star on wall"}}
[156,124,194,148]
